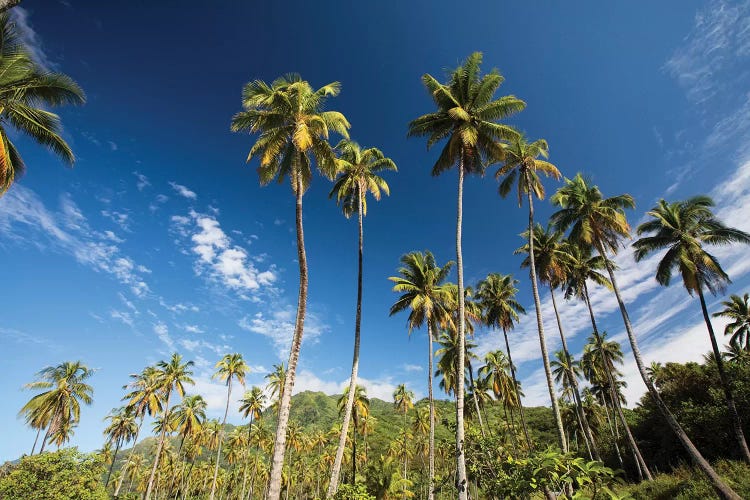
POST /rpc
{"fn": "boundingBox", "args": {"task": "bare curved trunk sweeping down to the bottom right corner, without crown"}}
[596,240,741,500]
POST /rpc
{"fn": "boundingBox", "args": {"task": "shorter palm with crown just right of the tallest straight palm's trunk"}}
[476,273,532,449]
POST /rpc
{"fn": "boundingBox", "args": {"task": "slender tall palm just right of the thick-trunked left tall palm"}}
[328,139,397,497]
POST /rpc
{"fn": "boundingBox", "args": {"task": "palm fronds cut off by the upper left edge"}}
[0,13,86,196]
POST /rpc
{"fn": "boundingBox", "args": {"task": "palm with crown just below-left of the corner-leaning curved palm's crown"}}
[515,224,601,460]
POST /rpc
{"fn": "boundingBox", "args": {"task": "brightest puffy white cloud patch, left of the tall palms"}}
[171,210,276,293]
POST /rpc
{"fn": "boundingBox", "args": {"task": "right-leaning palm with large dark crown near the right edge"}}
[633,196,750,462]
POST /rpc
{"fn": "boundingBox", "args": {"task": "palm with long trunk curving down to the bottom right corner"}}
[551,174,739,498]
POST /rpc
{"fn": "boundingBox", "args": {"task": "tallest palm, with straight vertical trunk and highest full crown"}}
[409,52,525,500]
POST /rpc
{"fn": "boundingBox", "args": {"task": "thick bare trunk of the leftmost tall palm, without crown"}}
[266,174,307,500]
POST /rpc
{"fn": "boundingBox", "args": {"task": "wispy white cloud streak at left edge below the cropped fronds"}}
[0,184,149,295]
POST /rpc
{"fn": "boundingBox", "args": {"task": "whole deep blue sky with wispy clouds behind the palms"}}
[0,0,750,460]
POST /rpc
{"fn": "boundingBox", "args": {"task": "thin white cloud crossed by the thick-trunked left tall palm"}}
[238,306,329,360]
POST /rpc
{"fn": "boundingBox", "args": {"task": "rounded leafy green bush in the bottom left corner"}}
[0,448,107,500]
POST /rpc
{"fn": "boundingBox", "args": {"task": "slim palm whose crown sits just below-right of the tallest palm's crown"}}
[495,136,567,452]
